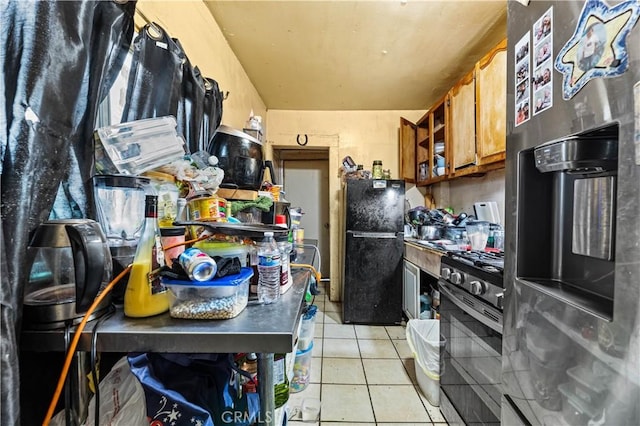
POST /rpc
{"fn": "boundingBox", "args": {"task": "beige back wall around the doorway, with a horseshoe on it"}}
[266,110,425,301]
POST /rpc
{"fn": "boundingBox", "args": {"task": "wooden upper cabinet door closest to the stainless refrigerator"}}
[476,39,507,164]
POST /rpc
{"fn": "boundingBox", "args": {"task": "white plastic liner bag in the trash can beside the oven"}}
[406,319,445,380]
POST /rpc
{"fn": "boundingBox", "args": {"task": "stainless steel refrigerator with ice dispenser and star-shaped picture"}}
[502,0,640,425]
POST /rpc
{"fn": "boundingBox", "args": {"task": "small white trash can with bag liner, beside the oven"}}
[407,319,446,407]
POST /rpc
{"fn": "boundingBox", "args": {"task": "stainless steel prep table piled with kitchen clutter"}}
[20,240,315,425]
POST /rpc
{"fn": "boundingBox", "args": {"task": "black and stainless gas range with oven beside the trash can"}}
[438,251,504,425]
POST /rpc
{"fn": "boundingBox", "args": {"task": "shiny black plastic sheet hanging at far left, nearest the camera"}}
[0,1,136,425]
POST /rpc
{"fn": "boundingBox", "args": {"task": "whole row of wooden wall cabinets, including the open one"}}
[400,39,507,186]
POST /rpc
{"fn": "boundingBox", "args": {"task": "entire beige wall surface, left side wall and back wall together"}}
[136,0,432,300]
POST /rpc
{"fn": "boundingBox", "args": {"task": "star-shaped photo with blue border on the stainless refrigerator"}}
[554,0,640,100]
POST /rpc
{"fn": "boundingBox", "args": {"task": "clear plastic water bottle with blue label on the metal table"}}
[258,232,281,304]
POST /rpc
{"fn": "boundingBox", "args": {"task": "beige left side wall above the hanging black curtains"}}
[135,0,266,129]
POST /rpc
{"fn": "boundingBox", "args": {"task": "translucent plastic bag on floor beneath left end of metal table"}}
[49,356,149,426]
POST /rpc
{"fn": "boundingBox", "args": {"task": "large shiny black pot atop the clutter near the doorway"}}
[207,125,276,190]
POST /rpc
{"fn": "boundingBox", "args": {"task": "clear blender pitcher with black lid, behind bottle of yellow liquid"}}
[93,175,153,303]
